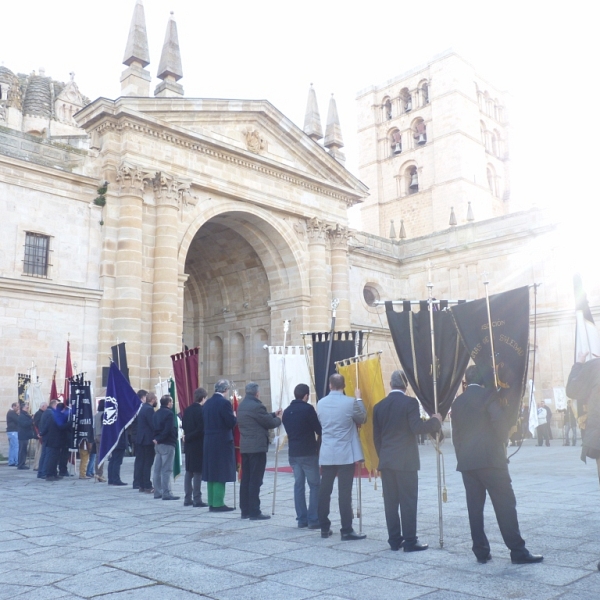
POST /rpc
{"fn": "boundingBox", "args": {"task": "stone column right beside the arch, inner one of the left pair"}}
[150,173,189,382]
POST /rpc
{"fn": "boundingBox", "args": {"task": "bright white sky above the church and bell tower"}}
[0,0,600,278]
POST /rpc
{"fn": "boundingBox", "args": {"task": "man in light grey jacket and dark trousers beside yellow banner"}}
[317,373,367,541]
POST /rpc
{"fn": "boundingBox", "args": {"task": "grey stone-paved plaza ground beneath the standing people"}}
[0,440,600,600]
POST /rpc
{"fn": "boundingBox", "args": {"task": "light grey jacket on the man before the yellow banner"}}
[317,391,367,465]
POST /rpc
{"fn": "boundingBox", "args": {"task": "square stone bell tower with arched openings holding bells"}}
[354,50,510,238]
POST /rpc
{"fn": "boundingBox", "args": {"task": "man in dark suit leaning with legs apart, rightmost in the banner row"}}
[452,365,544,564]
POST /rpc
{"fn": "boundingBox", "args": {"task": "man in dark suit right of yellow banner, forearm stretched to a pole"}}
[373,371,442,552]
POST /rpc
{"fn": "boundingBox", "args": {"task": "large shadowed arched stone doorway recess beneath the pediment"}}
[182,211,308,404]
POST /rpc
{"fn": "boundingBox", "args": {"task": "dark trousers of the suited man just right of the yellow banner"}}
[381,469,419,548]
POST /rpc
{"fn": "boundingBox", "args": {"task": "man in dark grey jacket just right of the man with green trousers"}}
[237,382,281,521]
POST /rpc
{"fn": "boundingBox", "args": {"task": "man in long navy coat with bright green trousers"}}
[202,379,237,512]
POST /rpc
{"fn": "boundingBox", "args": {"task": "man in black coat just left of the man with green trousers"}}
[182,388,208,508]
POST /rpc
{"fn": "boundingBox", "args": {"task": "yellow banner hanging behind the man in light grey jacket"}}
[337,355,386,474]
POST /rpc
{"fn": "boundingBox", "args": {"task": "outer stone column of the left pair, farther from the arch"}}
[112,163,152,388]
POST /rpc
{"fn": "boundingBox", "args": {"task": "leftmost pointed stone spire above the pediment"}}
[121,0,152,96]
